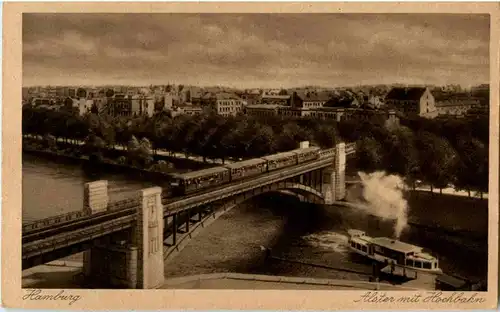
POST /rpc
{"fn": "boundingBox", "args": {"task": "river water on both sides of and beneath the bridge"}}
[23,155,488,286]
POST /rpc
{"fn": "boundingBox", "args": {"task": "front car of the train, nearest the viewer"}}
[170,167,231,196]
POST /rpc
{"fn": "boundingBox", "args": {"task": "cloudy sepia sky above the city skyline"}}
[22,13,490,88]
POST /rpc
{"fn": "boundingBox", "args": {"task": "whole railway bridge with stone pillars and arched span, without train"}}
[22,143,355,289]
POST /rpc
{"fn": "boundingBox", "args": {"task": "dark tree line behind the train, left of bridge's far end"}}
[22,106,339,161]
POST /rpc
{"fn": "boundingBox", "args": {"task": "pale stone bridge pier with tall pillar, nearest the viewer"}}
[83,187,164,289]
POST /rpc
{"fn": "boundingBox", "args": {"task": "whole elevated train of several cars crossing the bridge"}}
[170,146,335,196]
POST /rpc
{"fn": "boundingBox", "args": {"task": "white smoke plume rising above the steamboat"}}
[358,172,408,239]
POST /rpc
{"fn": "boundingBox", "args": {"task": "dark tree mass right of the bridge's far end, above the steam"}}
[353,116,489,196]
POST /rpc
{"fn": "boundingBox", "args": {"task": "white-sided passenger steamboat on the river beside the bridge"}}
[348,229,443,274]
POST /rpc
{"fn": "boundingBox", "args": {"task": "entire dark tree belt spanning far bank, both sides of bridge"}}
[22,106,489,196]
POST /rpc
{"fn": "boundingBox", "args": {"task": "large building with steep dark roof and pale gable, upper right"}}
[385,87,437,118]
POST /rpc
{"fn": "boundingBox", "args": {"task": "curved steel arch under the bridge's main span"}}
[163,181,325,262]
